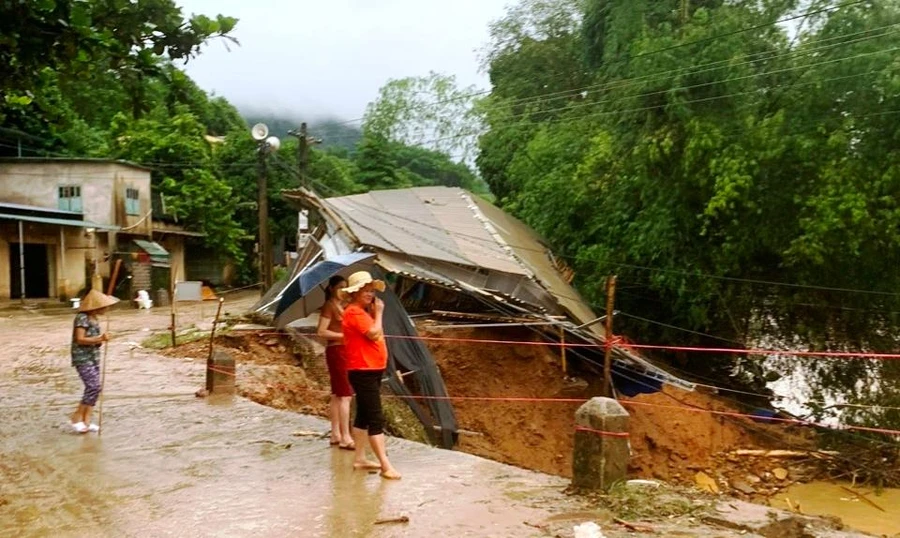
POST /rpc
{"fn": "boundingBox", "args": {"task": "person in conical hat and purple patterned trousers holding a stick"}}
[71,290,119,433]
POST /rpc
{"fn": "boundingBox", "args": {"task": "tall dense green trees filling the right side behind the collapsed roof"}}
[477,0,900,425]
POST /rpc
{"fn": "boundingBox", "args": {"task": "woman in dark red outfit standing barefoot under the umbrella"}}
[316,275,356,450]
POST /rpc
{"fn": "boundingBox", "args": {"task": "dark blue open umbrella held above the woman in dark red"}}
[275,252,375,329]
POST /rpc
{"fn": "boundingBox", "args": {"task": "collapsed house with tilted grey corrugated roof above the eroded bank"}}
[257,187,694,447]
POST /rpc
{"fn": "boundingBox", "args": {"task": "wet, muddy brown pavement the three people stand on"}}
[0,294,876,538]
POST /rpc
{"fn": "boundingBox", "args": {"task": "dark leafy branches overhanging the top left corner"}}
[0,0,237,98]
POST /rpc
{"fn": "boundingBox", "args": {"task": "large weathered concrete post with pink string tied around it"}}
[572,398,630,491]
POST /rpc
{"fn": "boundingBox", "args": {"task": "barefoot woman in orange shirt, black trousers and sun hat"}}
[341,271,400,480]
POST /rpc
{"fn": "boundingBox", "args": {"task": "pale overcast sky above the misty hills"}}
[177,0,510,120]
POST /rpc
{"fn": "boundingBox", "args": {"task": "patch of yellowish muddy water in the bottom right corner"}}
[771,482,900,536]
